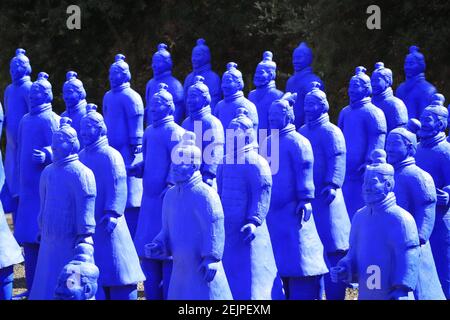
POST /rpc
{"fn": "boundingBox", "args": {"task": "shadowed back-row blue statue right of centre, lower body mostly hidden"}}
[285,42,324,129]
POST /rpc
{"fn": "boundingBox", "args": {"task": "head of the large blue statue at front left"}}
[52,117,80,161]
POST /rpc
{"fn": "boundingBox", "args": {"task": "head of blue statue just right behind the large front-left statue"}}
[80,103,107,146]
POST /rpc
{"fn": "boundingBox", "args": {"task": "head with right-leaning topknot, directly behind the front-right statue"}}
[386,119,420,165]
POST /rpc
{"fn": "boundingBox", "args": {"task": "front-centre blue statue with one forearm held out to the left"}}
[146,131,232,300]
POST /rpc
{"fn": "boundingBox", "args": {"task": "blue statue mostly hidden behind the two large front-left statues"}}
[61,71,87,149]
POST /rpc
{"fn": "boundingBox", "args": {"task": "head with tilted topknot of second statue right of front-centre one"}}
[269,92,297,130]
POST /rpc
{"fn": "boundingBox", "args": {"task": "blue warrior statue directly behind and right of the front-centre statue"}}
[217,108,284,300]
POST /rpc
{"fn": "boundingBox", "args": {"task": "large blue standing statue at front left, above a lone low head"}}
[30,117,96,300]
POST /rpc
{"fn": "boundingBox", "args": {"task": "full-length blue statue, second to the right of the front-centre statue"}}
[262,92,328,300]
